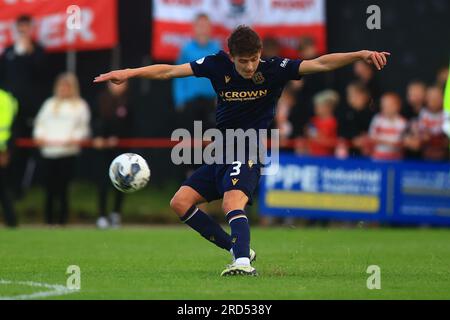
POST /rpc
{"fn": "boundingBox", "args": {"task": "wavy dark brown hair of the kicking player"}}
[228,25,262,57]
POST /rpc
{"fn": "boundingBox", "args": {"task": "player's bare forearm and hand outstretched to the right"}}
[299,50,391,75]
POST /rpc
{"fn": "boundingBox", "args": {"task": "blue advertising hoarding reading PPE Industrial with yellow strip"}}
[259,154,450,226]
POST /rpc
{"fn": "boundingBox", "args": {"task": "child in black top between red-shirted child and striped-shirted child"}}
[338,82,373,156]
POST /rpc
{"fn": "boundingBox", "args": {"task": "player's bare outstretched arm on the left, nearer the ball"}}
[94,63,194,84]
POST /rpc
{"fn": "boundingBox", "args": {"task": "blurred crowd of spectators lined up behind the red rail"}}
[0,15,449,227]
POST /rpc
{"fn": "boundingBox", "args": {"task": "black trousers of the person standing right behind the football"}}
[96,149,126,217]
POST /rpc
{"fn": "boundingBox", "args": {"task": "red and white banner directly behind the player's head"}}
[152,0,326,60]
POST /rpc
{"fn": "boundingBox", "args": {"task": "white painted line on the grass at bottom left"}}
[0,279,80,300]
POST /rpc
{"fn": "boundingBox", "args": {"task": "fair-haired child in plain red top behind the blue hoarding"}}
[305,90,339,156]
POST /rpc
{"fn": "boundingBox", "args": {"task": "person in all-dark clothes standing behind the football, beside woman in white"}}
[94,82,133,229]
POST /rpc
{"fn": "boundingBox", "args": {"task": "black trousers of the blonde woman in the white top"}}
[43,156,75,225]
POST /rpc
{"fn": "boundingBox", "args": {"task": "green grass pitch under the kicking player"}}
[0,226,450,299]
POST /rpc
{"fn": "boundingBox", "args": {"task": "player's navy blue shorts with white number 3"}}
[182,161,261,205]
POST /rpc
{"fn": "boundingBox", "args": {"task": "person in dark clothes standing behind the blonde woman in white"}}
[0,16,45,197]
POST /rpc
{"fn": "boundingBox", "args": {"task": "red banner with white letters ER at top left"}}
[0,0,117,52]
